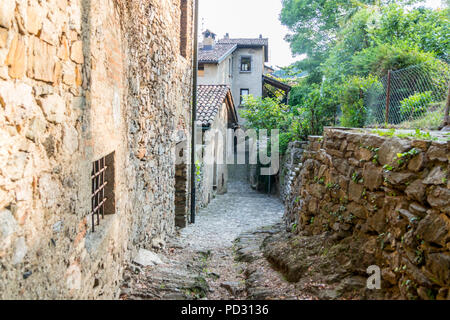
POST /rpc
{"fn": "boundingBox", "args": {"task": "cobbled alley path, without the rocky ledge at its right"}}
[121,166,314,299]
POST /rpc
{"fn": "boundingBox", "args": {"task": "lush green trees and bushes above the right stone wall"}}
[280,0,450,131]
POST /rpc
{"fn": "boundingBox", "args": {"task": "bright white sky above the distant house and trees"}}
[199,0,441,67]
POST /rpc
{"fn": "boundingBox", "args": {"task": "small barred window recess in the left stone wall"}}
[91,152,115,232]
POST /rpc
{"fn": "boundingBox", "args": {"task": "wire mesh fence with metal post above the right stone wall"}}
[364,63,450,129]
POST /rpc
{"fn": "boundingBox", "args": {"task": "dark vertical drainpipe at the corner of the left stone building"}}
[191,0,198,223]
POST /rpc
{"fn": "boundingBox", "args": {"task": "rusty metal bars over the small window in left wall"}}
[91,157,108,232]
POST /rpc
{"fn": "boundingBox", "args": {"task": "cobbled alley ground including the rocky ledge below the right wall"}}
[121,162,380,300]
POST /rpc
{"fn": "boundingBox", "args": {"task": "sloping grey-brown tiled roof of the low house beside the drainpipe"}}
[197,85,230,127]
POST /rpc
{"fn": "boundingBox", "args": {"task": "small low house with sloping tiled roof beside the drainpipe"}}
[196,85,238,206]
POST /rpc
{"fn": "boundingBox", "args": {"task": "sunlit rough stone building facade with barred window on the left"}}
[0,0,194,299]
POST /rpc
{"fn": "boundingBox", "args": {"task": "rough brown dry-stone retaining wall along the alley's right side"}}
[286,128,450,299]
